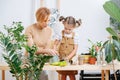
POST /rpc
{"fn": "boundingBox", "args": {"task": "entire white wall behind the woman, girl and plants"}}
[0,0,109,80]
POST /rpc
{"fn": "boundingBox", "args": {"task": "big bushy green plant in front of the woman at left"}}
[0,22,51,80]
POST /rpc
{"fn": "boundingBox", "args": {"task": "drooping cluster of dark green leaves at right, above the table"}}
[102,38,120,63]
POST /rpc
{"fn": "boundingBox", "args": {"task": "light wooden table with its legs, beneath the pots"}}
[0,63,120,80]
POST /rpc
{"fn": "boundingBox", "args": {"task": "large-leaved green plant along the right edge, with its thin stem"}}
[101,1,120,80]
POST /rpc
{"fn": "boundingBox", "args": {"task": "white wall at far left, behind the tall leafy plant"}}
[0,0,33,80]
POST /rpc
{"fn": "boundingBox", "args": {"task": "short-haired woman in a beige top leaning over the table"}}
[25,7,57,80]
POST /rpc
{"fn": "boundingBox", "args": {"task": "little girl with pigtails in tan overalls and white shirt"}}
[54,16,81,80]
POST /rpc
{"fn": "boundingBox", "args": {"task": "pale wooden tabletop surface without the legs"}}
[0,62,120,70]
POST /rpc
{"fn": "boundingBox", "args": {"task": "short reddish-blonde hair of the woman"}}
[36,7,50,21]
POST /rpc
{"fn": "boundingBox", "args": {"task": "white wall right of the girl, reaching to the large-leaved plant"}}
[60,0,109,53]
